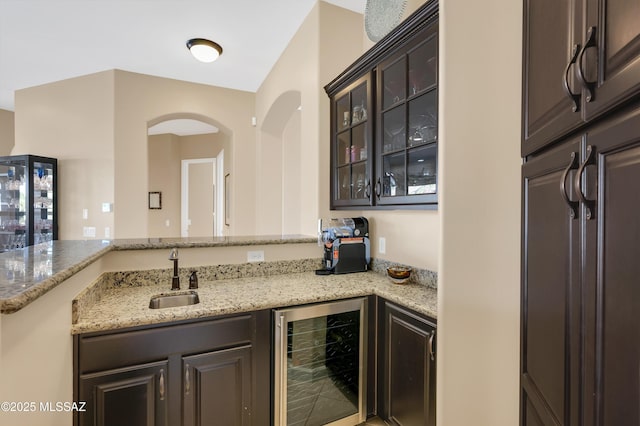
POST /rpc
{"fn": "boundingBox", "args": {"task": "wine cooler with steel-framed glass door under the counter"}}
[274,298,367,426]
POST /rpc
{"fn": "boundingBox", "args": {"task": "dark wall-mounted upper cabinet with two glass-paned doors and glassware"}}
[325,0,438,209]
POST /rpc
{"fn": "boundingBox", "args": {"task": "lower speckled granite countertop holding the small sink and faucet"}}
[71,271,437,334]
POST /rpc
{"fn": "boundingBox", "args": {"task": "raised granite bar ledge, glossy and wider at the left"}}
[0,235,317,314]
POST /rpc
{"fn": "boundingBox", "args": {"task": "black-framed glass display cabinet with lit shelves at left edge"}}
[0,155,57,252]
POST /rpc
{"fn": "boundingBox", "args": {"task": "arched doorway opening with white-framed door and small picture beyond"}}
[147,114,230,237]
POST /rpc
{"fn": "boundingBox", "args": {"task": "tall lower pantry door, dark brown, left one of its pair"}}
[521,139,580,425]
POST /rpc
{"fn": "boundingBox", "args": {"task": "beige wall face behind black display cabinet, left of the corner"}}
[12,71,115,239]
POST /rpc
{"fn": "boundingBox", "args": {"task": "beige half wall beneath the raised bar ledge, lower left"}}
[0,259,102,426]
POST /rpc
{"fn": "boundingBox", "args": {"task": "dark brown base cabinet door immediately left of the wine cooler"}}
[183,346,252,426]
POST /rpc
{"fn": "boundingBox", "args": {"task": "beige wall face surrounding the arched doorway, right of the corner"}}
[115,71,256,238]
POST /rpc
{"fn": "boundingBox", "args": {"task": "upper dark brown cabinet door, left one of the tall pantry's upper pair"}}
[522,0,582,156]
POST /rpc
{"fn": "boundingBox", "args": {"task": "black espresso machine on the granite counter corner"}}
[316,217,371,274]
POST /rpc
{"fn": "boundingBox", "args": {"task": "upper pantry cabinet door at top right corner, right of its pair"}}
[581,0,640,120]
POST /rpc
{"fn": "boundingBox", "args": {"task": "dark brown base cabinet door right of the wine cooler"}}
[378,299,436,426]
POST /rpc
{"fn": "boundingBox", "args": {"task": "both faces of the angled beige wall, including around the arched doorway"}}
[12,70,256,239]
